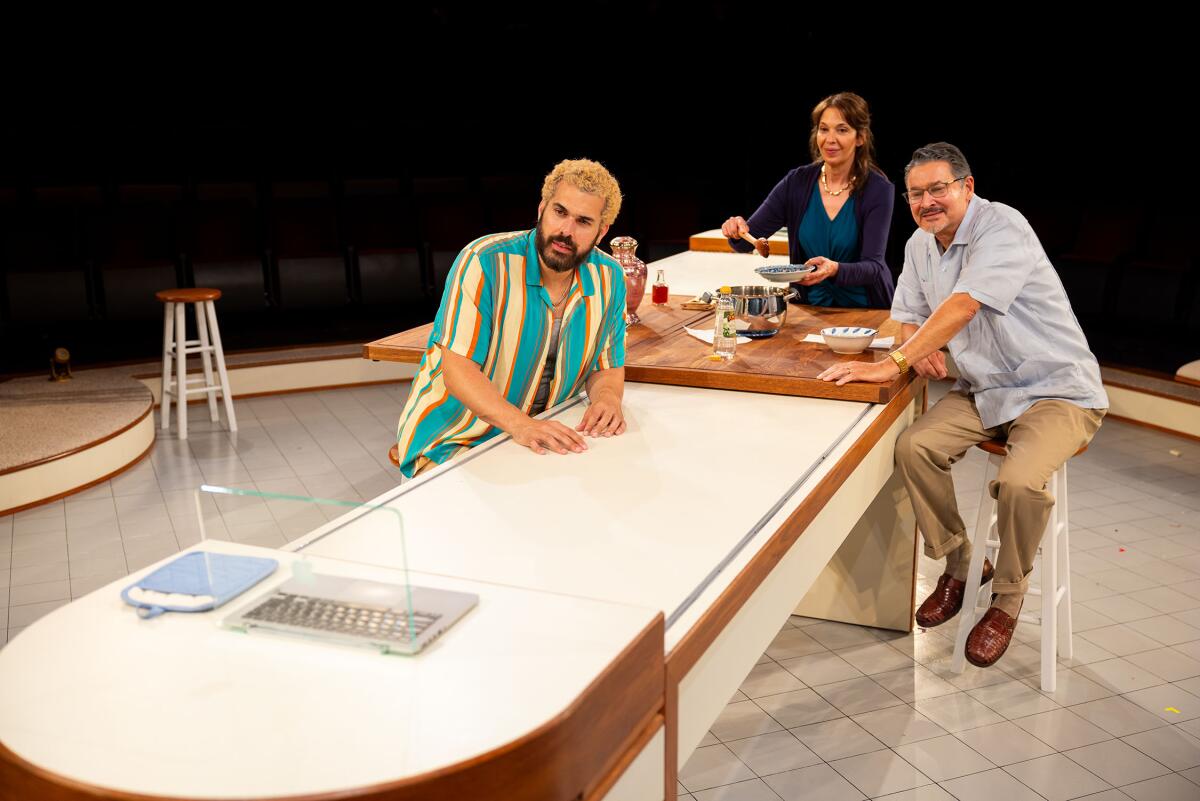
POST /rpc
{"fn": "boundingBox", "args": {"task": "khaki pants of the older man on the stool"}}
[896,392,1106,595]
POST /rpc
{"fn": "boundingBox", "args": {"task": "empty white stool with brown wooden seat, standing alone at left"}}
[155,288,238,439]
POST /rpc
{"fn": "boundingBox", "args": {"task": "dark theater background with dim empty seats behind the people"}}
[0,8,1200,375]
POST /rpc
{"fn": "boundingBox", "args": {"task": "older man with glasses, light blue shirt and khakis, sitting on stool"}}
[821,141,1108,667]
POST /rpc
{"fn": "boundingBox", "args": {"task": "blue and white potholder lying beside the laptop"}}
[121,550,280,618]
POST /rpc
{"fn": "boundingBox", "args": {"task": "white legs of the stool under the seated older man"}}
[950,439,1087,693]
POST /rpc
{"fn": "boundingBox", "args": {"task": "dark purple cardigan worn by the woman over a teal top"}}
[730,162,895,308]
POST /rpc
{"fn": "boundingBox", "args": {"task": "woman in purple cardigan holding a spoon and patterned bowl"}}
[721,92,895,308]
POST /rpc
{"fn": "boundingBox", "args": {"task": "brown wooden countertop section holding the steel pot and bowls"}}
[362,295,912,403]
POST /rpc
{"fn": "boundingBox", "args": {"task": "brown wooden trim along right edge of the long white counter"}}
[666,379,925,687]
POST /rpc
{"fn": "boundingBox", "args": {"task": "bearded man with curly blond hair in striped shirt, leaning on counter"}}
[397,158,625,477]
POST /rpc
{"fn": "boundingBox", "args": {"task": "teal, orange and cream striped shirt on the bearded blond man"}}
[396,230,625,477]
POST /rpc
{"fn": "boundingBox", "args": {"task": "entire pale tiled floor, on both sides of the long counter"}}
[0,385,1200,801]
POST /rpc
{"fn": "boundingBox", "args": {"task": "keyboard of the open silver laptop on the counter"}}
[242,592,442,643]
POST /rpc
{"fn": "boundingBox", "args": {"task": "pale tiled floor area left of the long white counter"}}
[0,384,408,644]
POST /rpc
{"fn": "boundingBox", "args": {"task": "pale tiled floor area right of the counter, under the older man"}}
[678,383,1200,801]
